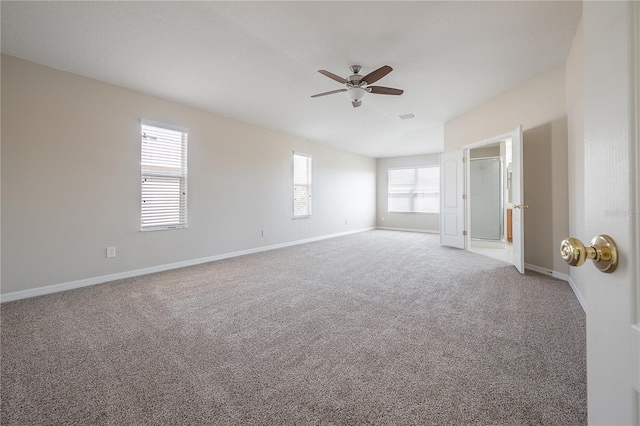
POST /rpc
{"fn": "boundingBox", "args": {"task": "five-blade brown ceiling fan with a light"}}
[311,65,404,108]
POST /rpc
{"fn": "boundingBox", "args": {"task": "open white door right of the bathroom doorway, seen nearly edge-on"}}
[511,126,526,274]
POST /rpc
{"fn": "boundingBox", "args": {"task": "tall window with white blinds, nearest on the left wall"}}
[140,120,188,231]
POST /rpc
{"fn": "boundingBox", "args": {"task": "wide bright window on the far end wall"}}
[388,166,440,213]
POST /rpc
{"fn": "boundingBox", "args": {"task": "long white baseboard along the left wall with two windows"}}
[0,228,376,303]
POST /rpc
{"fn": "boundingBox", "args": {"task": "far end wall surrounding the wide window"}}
[377,154,440,232]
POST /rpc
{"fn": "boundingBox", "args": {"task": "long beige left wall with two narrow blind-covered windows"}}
[1,55,376,294]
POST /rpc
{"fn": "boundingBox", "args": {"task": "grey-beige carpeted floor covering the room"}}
[0,231,586,425]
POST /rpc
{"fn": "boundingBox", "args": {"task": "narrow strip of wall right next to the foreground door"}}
[566,15,593,308]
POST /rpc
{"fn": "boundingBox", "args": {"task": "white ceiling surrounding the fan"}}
[1,1,582,157]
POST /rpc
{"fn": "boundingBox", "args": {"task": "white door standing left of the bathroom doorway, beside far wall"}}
[440,150,465,249]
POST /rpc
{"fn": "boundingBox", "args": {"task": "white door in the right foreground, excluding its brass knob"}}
[584,2,640,425]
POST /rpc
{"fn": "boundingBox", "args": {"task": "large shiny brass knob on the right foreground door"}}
[560,235,618,273]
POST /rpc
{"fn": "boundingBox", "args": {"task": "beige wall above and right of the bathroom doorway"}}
[444,65,569,274]
